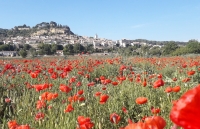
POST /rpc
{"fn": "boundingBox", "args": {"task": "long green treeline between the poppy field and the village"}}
[0,40,200,57]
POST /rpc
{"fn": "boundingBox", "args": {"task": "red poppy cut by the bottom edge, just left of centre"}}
[77,116,94,129]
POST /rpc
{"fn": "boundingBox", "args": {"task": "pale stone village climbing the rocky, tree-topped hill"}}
[0,21,191,56]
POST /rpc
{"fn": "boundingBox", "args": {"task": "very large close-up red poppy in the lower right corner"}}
[170,85,200,129]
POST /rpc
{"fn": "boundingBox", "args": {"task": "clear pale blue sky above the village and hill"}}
[0,0,200,41]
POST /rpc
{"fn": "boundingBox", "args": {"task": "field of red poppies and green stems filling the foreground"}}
[0,55,200,129]
